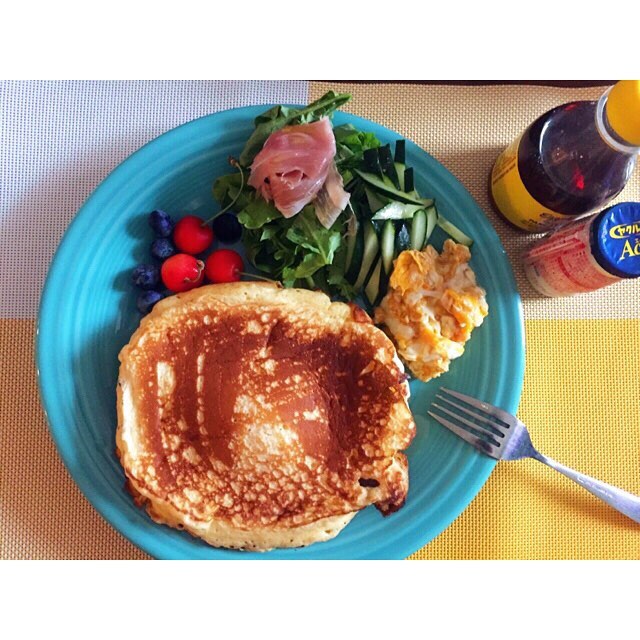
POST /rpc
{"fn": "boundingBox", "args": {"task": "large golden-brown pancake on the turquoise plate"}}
[116,282,415,550]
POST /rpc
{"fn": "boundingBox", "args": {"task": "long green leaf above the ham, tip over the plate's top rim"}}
[240,91,351,167]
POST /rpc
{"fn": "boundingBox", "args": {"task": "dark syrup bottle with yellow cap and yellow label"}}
[491,80,640,233]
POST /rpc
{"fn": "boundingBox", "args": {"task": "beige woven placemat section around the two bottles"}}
[309,82,640,318]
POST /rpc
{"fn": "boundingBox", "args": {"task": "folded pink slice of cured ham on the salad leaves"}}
[249,118,339,218]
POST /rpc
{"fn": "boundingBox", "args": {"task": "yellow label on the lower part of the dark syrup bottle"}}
[491,136,576,232]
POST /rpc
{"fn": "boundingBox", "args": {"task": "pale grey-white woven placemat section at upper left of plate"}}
[0,80,308,318]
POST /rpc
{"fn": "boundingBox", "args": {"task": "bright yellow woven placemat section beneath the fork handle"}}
[412,320,640,560]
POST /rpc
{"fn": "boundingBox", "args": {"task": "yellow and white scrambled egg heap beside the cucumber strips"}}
[375,240,489,382]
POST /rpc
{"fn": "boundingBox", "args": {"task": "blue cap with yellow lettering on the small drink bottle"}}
[591,202,640,278]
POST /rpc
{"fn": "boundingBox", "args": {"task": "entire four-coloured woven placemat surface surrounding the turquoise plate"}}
[0,81,640,559]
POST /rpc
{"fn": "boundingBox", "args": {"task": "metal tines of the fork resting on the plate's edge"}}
[427,387,513,458]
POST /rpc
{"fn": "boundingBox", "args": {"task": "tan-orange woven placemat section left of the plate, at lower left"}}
[0,319,147,560]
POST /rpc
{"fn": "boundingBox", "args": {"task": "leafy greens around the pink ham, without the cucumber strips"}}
[213,91,432,300]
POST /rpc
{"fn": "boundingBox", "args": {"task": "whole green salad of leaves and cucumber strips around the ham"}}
[213,91,471,305]
